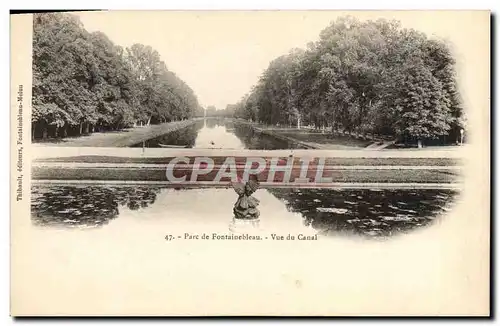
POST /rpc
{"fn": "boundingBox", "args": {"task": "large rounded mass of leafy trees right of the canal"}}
[226,16,464,140]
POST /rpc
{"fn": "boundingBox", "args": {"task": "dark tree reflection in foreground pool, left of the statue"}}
[31,186,160,228]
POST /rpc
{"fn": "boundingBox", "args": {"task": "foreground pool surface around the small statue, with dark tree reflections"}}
[31,186,457,238]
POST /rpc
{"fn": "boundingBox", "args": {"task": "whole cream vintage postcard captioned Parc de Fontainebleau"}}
[10,11,491,316]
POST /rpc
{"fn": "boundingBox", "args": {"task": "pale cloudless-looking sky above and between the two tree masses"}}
[78,11,488,109]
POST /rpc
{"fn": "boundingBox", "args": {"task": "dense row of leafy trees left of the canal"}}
[32,13,202,139]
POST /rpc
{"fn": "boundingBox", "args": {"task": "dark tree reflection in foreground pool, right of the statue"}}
[269,189,458,237]
